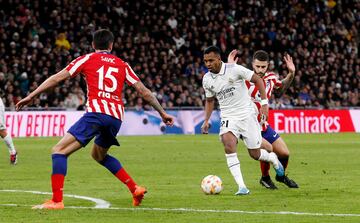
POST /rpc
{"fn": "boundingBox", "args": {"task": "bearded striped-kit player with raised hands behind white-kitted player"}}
[228,50,299,190]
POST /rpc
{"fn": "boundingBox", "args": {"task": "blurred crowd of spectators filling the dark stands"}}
[0,0,360,110]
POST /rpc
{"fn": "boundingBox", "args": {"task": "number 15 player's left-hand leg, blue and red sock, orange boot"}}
[33,133,82,209]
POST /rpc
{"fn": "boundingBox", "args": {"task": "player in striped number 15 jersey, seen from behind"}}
[16,29,174,209]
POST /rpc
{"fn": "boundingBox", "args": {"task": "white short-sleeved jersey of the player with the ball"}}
[203,62,256,120]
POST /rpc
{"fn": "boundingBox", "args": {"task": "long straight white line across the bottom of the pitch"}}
[0,204,360,217]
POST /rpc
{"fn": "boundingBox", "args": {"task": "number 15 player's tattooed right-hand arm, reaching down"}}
[132,81,174,126]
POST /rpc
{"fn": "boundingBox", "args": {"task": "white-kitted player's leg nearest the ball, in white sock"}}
[221,132,250,195]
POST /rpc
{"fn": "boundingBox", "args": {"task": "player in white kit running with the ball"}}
[201,46,284,195]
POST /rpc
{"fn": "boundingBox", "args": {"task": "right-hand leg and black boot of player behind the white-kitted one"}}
[272,137,299,188]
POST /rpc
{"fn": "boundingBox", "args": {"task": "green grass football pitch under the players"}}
[0,133,360,223]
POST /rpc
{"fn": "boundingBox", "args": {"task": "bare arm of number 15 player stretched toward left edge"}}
[15,69,70,111]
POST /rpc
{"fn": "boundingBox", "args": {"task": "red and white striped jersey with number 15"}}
[65,52,139,120]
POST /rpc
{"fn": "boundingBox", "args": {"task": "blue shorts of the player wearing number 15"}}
[68,112,122,148]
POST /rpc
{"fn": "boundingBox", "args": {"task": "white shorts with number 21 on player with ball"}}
[219,114,262,149]
